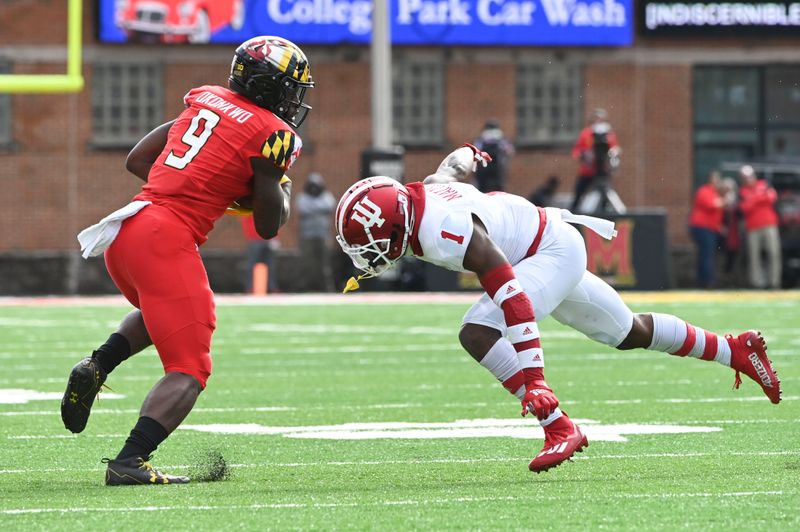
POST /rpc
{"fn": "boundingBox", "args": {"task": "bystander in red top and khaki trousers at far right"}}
[739,165,781,288]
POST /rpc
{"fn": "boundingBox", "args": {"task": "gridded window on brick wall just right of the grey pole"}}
[392,58,444,147]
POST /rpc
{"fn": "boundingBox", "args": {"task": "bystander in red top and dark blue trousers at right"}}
[689,170,725,288]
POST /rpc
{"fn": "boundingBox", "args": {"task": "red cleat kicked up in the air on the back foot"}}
[725,331,781,404]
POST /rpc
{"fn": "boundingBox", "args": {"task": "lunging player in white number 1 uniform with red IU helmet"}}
[335,144,781,473]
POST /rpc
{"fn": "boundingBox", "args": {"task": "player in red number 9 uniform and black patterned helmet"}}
[61,36,314,485]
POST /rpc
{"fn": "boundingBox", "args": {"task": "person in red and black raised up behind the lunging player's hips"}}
[570,109,620,212]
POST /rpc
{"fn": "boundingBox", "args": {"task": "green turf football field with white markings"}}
[0,292,800,531]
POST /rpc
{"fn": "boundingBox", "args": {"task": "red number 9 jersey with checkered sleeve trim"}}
[134,85,303,244]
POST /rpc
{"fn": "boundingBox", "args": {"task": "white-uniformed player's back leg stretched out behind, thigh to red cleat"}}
[553,272,780,403]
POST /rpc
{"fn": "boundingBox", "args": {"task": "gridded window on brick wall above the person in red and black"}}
[517,63,583,145]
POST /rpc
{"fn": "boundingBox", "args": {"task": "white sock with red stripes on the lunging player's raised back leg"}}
[647,312,731,366]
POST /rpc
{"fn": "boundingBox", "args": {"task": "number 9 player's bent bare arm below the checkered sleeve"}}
[250,157,292,239]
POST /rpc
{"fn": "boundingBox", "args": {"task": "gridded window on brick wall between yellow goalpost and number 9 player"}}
[92,61,163,147]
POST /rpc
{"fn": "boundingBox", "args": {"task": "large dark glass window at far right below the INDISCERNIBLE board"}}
[693,65,800,186]
